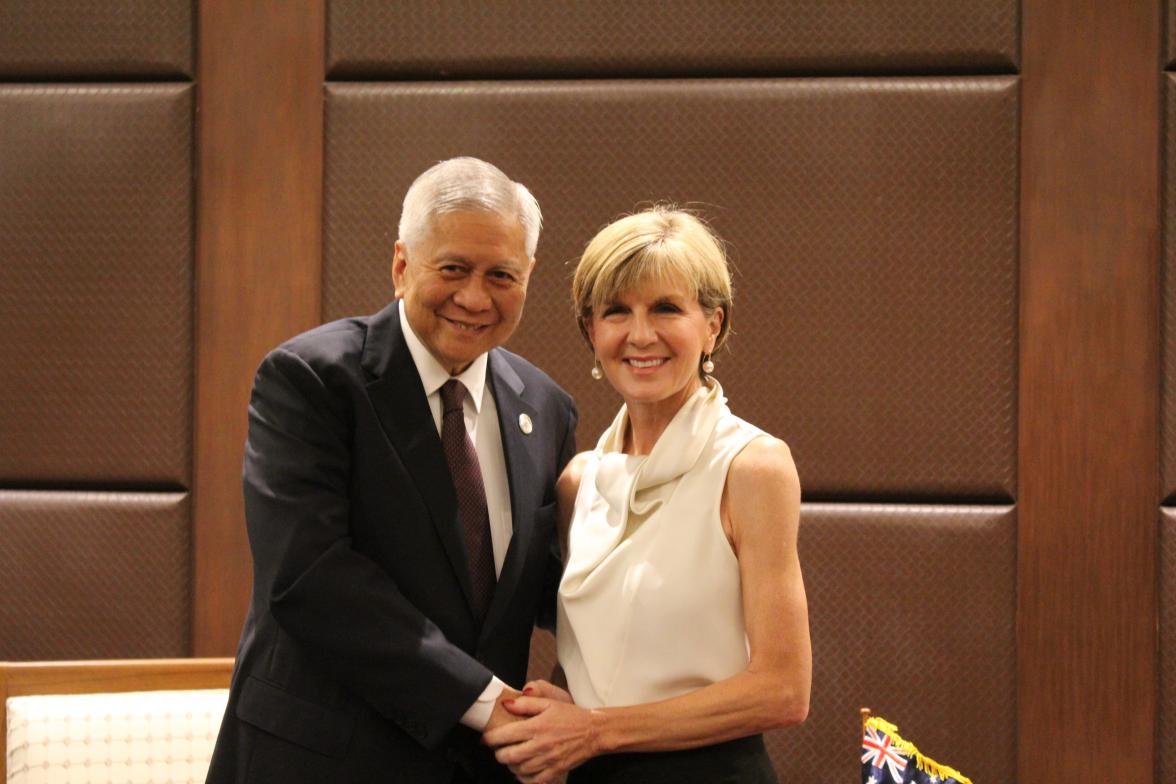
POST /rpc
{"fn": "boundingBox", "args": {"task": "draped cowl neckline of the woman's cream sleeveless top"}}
[560,376,728,587]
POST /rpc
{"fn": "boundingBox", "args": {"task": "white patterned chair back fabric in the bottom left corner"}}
[7,689,228,784]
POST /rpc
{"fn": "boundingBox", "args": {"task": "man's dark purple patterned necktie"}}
[441,378,497,621]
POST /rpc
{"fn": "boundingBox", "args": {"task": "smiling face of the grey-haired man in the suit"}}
[392,210,535,375]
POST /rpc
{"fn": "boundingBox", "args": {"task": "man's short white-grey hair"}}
[399,158,543,259]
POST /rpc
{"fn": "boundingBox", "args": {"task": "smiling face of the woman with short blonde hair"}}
[588,272,723,414]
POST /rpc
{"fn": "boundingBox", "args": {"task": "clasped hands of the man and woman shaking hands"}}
[482,681,599,784]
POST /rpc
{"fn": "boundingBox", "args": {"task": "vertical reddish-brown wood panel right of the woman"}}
[1018,0,1160,783]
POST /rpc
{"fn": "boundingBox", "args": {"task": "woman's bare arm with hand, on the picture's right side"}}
[486,438,811,782]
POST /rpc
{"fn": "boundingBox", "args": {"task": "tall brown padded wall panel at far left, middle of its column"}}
[0,85,193,487]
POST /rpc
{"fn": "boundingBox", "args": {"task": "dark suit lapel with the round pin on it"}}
[482,349,543,638]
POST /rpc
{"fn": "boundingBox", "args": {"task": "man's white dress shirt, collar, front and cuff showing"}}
[400,301,514,731]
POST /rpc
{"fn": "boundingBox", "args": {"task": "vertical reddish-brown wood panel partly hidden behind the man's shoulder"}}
[193,0,325,656]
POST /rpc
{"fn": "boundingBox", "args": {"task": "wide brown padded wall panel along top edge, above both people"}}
[327,0,1020,79]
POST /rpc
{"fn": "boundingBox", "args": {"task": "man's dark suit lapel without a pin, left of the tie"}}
[362,302,473,608]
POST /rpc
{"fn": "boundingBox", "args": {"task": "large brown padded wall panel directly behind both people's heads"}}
[323,78,1017,500]
